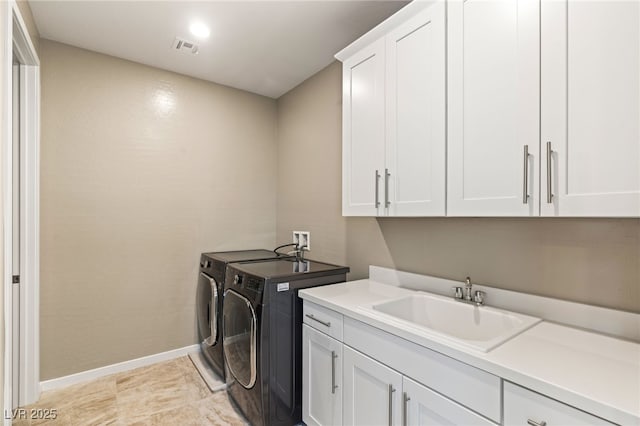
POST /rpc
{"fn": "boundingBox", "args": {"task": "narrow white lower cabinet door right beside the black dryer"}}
[302,324,342,426]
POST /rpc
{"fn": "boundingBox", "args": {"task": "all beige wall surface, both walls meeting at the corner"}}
[40,40,640,380]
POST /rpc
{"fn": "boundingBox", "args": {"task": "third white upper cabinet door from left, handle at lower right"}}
[447,0,540,216]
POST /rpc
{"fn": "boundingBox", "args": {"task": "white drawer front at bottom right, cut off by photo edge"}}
[504,381,613,426]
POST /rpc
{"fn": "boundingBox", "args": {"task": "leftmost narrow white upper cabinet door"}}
[342,39,385,216]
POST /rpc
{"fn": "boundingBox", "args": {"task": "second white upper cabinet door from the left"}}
[383,1,446,216]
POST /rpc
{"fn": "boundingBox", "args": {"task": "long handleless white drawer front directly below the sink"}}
[344,318,501,422]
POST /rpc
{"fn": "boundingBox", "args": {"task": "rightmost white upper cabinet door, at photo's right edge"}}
[541,0,640,216]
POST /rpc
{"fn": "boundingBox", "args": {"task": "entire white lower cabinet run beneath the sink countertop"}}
[302,300,613,426]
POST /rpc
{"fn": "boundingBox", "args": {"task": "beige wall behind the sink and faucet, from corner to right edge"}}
[277,63,640,312]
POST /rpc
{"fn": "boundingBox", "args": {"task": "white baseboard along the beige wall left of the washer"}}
[40,344,200,392]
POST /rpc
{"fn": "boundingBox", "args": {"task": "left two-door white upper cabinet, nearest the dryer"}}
[342,1,446,216]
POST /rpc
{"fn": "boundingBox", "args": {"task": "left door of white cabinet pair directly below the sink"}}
[343,346,402,426]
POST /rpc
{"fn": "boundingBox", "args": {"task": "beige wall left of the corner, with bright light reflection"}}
[40,40,277,380]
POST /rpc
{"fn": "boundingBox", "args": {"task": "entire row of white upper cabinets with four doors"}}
[336,0,640,217]
